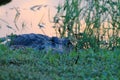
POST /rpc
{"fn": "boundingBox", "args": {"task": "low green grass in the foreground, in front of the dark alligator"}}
[0,45,120,80]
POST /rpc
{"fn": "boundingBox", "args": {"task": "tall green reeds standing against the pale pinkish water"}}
[54,0,120,49]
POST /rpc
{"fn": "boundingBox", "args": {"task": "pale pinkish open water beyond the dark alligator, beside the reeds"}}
[0,0,62,37]
